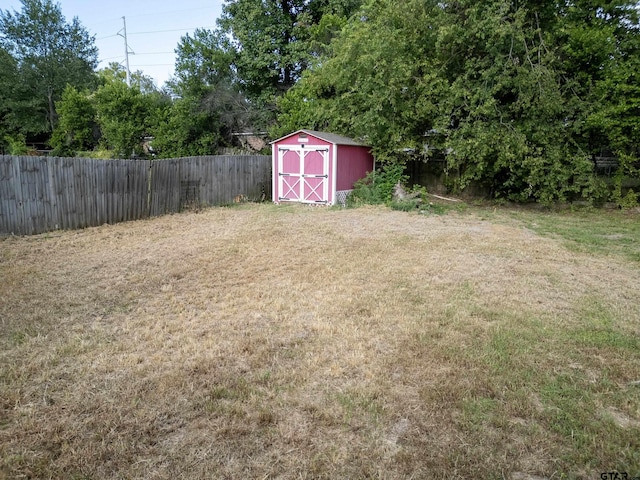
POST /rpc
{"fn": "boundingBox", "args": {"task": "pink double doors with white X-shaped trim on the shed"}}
[278,145,329,203]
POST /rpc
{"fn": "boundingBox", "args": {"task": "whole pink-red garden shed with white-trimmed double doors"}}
[271,130,374,205]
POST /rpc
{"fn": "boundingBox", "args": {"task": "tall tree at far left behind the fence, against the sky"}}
[0,0,98,133]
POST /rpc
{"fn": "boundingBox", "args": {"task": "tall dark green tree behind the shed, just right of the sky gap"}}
[219,0,362,118]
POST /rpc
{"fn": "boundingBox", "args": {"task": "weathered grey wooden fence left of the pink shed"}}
[0,155,271,235]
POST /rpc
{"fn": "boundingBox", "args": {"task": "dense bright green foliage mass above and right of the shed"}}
[278,0,640,203]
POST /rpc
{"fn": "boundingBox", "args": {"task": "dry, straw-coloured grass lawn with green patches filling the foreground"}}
[0,205,640,479]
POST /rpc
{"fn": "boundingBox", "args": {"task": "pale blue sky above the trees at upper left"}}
[0,0,223,87]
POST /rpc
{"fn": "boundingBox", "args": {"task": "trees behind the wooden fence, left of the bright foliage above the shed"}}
[0,0,360,157]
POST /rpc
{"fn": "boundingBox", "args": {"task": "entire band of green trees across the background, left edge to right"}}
[0,0,640,204]
